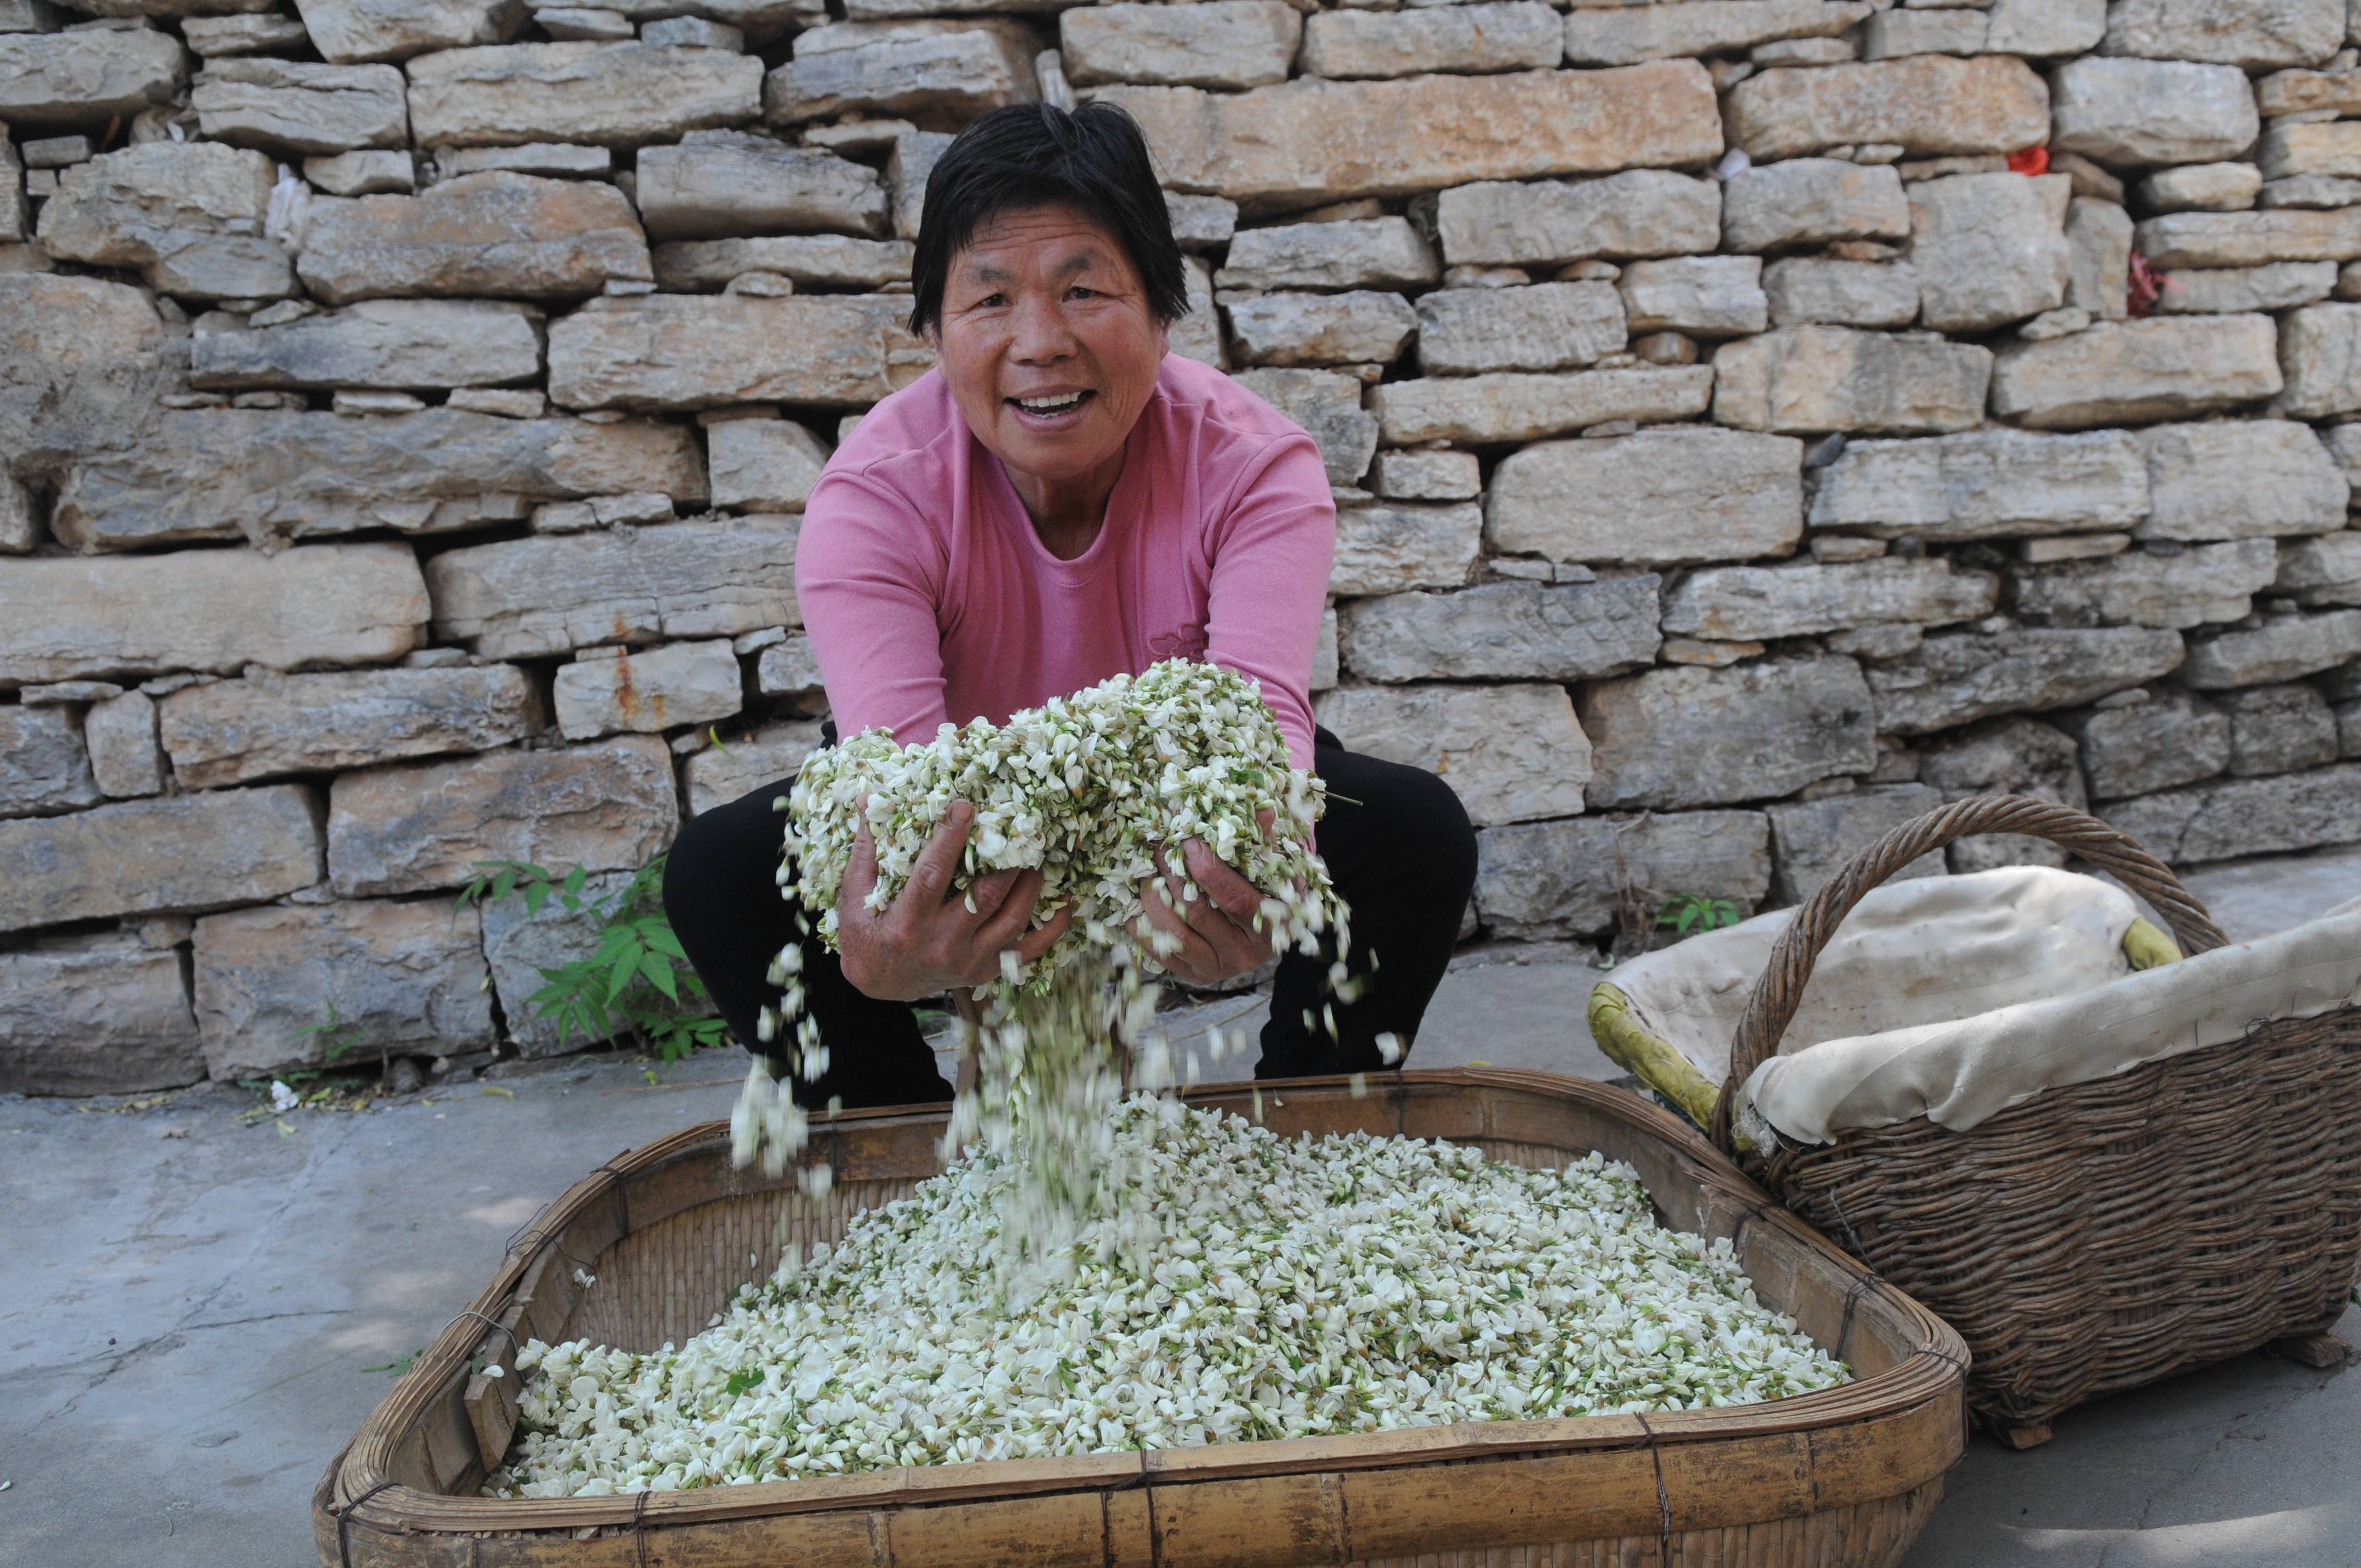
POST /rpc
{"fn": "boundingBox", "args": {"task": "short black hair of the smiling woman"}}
[909,104,1188,337]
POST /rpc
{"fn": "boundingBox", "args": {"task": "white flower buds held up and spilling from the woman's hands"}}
[732,659,1351,1287]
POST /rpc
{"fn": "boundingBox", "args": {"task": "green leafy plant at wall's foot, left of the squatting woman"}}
[458,855,730,1063]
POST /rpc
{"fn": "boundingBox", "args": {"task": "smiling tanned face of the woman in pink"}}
[935,208,1164,484]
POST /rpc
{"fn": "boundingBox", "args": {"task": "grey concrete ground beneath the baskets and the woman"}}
[0,850,2361,1568]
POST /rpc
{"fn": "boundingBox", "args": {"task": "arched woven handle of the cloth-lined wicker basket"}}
[1712,796,2229,1155]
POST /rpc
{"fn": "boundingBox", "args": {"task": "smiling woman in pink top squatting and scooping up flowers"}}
[663,104,1476,1108]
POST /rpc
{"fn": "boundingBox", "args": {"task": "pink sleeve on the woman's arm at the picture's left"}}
[796,470,949,746]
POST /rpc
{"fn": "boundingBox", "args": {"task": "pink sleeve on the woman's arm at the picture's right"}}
[1204,432,1336,772]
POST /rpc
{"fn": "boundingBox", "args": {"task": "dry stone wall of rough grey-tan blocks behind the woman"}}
[0,0,2361,1093]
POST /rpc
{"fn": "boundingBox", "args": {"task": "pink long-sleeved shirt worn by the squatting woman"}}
[796,354,1336,770]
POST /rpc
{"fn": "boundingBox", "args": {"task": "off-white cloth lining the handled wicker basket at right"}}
[1615,867,2361,1143]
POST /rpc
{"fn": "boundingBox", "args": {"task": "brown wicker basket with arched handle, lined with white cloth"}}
[1714,796,2361,1447]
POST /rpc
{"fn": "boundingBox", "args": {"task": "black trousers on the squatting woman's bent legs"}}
[663,729,1476,1110]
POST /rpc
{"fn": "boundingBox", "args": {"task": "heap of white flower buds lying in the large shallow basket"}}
[484,1096,1849,1497]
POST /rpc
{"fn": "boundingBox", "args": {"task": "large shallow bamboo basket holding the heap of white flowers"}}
[312,1070,1965,1568]
